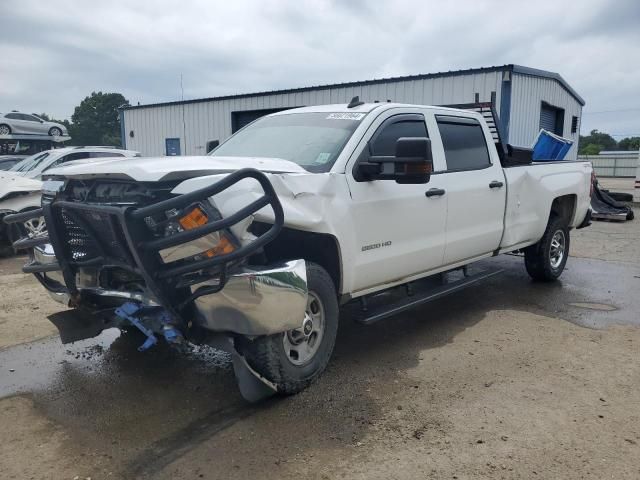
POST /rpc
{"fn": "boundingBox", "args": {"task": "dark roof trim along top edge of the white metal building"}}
[121,64,585,110]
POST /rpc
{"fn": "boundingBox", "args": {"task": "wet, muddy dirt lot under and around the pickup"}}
[0,214,640,479]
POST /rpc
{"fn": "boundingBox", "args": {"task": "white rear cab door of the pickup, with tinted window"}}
[431,112,506,265]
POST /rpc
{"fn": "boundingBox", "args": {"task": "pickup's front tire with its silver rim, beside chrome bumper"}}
[238,262,338,395]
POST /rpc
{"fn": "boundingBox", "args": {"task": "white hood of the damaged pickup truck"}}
[46,156,307,182]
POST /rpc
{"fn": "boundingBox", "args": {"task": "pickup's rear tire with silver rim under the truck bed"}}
[524,214,569,282]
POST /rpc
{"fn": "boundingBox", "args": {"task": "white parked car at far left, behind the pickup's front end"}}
[0,147,141,255]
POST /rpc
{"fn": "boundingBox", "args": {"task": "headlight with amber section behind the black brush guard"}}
[159,205,236,263]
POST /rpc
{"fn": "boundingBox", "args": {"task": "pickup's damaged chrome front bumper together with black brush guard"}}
[6,169,307,336]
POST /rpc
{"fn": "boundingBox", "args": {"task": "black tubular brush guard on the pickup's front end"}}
[4,168,284,315]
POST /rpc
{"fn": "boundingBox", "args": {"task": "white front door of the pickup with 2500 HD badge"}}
[347,109,447,292]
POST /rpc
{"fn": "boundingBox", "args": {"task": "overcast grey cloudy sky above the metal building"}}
[0,0,640,138]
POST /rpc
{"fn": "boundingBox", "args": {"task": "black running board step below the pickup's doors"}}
[356,269,504,325]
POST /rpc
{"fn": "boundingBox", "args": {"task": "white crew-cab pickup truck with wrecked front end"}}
[6,98,591,400]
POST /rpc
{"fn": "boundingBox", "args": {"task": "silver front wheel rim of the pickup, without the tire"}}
[282,291,325,366]
